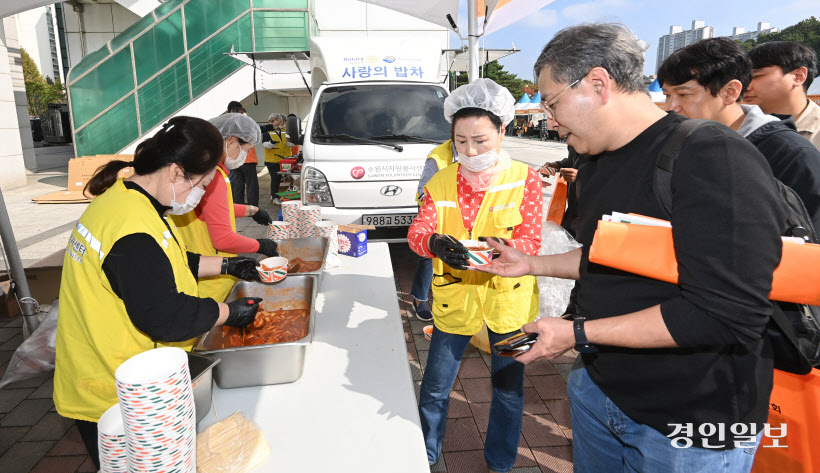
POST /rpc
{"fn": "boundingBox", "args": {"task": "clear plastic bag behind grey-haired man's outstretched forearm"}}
[536,222,582,320]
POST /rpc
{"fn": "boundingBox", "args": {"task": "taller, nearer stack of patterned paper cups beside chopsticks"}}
[114,347,196,473]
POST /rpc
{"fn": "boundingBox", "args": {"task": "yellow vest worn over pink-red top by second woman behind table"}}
[171,166,236,302]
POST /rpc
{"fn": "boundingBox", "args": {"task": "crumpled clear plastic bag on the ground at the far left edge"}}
[0,300,59,389]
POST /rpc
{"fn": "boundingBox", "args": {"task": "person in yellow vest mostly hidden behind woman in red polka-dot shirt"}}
[410,132,458,322]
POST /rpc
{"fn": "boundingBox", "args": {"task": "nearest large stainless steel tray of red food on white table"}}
[194,274,318,389]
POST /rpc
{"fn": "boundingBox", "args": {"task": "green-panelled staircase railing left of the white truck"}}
[66,0,316,156]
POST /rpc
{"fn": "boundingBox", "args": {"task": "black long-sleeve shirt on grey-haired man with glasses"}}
[578,113,785,448]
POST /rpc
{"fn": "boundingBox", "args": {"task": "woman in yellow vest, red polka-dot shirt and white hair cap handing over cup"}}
[408,79,542,472]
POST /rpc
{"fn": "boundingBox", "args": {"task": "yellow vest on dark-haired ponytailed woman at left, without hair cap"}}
[54,179,198,422]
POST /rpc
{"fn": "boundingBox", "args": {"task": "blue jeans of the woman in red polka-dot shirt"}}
[419,328,524,471]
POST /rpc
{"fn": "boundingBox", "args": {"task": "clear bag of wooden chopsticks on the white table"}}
[196,412,270,473]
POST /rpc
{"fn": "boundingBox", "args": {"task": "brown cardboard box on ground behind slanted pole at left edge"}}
[0,250,65,318]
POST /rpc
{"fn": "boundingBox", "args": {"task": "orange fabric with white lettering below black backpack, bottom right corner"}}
[752,369,820,473]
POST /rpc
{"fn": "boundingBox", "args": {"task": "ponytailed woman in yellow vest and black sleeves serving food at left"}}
[54,117,261,466]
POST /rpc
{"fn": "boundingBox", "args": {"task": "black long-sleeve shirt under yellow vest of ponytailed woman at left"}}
[102,181,219,342]
